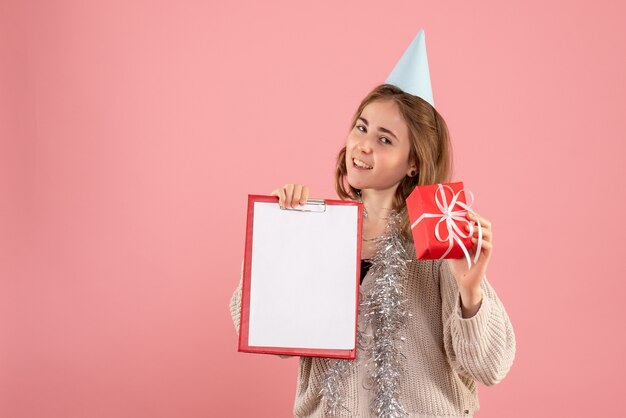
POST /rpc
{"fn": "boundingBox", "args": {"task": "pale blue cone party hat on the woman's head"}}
[385,29,435,107]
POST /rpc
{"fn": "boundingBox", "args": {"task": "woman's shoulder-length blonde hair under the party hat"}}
[335,84,452,239]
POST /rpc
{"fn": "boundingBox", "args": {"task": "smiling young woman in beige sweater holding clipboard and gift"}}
[230,84,515,418]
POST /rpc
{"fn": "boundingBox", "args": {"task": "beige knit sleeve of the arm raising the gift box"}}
[438,260,515,386]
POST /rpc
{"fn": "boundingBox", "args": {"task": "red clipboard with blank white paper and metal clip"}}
[238,195,363,359]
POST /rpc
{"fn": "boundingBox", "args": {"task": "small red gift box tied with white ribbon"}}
[406,182,482,268]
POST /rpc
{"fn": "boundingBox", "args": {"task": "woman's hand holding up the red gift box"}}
[447,212,493,296]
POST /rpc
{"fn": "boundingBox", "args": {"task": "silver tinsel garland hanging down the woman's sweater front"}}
[321,210,411,418]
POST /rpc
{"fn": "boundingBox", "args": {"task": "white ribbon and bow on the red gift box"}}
[411,183,483,269]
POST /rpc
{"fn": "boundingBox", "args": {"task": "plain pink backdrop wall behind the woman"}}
[0,0,626,418]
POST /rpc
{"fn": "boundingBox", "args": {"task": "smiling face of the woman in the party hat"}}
[346,99,416,190]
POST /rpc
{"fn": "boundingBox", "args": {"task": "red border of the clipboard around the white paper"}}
[238,195,363,360]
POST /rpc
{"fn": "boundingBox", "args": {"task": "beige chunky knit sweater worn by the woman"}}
[230,242,515,418]
